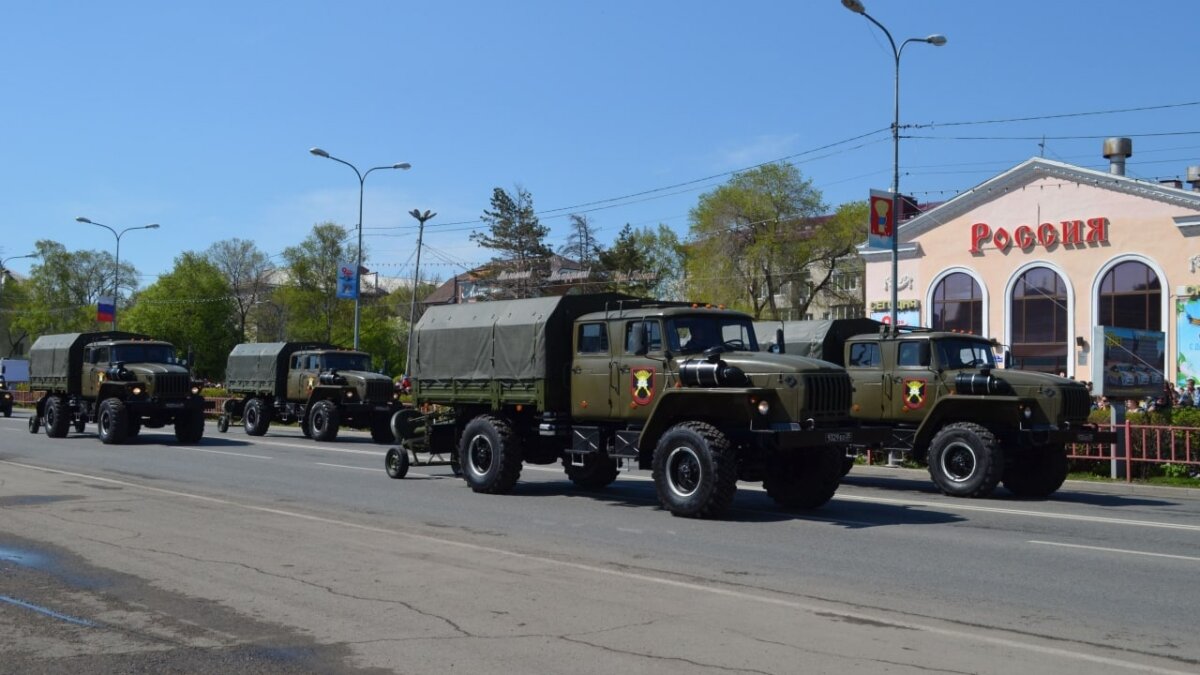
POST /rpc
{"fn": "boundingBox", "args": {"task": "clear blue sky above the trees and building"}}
[0,0,1200,285]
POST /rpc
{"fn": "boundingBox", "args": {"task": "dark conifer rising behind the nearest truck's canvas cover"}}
[470,186,552,298]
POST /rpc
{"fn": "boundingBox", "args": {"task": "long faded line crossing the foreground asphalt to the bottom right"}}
[0,460,1193,675]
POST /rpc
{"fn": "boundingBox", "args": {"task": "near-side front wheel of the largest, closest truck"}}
[653,422,738,518]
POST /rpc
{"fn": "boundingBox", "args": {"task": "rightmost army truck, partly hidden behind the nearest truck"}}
[757,318,1116,498]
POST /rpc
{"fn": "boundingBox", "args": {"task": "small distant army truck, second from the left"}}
[217,342,400,443]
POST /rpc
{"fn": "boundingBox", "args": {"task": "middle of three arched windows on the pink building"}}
[1010,267,1069,374]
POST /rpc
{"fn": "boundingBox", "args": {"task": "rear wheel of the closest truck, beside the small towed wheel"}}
[458,414,521,495]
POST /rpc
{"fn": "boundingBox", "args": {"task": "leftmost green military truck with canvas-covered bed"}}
[29,331,204,443]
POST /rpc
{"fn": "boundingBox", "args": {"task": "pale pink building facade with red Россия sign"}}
[862,151,1200,383]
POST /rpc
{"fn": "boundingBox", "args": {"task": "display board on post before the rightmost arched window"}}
[1092,325,1166,401]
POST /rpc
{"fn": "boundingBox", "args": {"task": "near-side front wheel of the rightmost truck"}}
[929,422,1004,497]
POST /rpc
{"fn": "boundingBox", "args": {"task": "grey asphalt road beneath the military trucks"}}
[0,411,1200,674]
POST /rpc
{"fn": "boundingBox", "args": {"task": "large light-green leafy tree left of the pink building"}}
[688,163,859,318]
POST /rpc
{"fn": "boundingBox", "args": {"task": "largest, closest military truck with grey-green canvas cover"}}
[386,294,882,518]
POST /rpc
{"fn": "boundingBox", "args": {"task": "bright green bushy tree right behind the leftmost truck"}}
[120,251,238,381]
